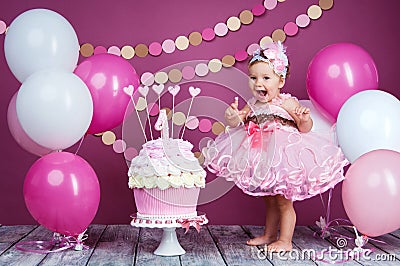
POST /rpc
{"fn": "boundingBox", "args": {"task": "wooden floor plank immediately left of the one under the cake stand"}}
[88,225,139,265]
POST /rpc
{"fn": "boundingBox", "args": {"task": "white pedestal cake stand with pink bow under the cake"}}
[131,213,208,256]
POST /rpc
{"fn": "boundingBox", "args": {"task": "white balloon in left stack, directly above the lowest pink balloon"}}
[16,70,93,150]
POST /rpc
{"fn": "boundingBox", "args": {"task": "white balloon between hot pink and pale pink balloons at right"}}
[336,90,400,163]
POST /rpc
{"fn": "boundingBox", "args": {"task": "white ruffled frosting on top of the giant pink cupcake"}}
[128,138,206,190]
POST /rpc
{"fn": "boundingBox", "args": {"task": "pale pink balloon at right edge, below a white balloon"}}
[342,150,400,237]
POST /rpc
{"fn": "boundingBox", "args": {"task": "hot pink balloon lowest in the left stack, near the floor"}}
[24,152,100,236]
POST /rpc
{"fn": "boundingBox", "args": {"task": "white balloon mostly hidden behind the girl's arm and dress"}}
[299,100,336,143]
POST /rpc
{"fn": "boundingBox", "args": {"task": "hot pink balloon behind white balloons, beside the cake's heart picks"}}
[74,54,139,134]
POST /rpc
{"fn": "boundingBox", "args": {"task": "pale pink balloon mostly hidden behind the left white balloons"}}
[7,93,52,156]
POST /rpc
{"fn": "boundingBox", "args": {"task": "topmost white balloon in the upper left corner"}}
[4,9,79,82]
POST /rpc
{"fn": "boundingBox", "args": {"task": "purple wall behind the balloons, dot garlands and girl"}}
[0,0,400,225]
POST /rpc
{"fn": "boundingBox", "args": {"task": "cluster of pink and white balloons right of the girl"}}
[307,43,400,236]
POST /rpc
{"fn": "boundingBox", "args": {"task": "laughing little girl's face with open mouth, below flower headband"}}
[249,61,285,103]
